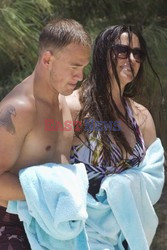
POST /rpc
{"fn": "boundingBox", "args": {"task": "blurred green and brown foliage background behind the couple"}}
[0,0,167,250]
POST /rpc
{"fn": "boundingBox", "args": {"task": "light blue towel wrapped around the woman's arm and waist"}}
[86,139,164,250]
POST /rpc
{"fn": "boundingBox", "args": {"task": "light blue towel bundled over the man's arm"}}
[7,163,89,250]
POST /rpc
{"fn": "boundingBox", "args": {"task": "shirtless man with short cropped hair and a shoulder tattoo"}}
[0,19,90,250]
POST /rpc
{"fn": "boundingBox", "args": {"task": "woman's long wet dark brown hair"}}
[76,25,159,169]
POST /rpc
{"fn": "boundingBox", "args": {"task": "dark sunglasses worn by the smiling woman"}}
[112,44,145,63]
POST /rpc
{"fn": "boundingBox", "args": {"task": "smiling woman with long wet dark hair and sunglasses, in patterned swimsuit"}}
[67,25,163,249]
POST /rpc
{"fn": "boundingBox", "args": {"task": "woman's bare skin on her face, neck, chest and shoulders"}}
[66,33,156,152]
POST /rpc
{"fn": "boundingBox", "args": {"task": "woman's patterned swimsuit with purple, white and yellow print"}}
[71,100,146,198]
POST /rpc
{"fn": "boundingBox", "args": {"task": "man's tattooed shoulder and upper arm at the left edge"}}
[0,87,35,173]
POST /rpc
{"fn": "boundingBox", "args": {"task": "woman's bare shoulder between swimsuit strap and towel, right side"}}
[129,99,156,148]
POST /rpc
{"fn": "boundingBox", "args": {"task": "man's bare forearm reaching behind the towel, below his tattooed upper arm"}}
[0,172,25,201]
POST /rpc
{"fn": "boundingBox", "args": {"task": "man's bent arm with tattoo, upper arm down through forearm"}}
[0,101,34,201]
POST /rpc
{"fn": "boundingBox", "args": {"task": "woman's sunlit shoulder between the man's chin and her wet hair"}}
[66,89,81,120]
